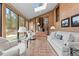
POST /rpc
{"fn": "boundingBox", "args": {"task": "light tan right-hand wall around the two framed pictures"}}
[55,3,79,32]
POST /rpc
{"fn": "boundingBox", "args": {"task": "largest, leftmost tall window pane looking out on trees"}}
[6,8,18,41]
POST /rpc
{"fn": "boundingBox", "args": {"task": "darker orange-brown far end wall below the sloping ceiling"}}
[31,11,55,31]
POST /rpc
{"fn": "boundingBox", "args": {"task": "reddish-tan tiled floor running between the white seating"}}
[27,37,56,56]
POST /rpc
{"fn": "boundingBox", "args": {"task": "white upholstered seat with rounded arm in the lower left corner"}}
[0,37,26,56]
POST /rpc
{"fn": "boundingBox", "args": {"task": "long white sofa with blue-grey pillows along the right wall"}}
[47,31,79,56]
